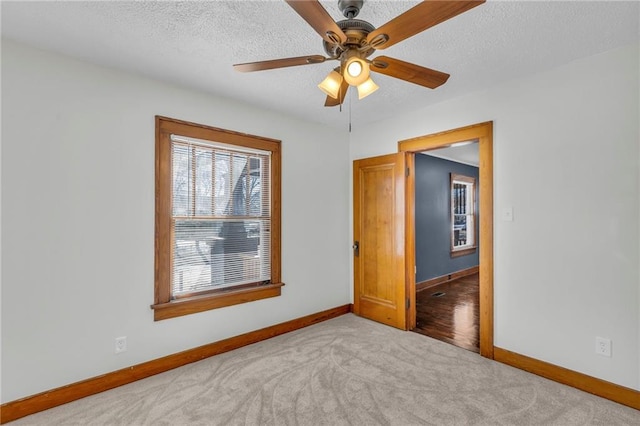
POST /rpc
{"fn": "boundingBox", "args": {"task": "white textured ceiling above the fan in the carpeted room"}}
[1,0,640,128]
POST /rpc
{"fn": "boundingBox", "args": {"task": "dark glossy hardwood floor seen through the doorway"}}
[412,274,480,352]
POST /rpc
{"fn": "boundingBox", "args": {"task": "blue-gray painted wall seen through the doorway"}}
[415,154,479,283]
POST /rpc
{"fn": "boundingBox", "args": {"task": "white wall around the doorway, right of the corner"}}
[350,44,640,389]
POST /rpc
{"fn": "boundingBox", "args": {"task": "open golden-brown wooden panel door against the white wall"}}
[353,152,408,330]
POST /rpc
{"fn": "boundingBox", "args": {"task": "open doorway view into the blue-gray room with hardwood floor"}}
[412,141,480,352]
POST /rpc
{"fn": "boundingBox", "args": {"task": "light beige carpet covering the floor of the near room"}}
[12,314,640,426]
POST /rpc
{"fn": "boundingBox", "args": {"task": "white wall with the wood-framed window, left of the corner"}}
[2,40,350,402]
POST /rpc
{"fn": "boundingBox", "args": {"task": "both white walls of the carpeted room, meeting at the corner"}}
[1,40,640,402]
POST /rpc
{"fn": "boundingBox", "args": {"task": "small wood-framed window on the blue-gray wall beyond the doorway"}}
[451,173,476,257]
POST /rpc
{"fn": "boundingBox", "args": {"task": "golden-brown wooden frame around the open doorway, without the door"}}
[398,121,493,359]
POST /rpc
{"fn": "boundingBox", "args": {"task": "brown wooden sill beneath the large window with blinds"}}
[151,283,284,321]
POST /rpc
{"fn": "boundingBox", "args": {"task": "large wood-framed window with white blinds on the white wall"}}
[152,117,283,321]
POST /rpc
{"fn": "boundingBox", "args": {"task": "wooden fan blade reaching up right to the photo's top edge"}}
[367,0,485,49]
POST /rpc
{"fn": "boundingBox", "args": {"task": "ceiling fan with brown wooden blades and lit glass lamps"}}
[233,0,485,106]
